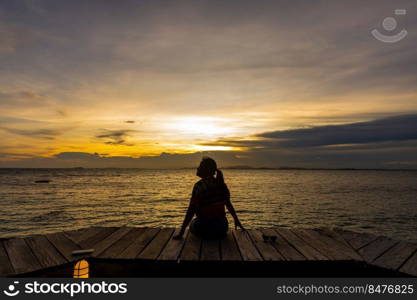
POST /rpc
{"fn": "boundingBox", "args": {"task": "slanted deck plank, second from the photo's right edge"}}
[373,242,417,270]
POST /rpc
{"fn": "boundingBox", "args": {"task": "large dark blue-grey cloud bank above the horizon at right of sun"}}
[188,114,417,168]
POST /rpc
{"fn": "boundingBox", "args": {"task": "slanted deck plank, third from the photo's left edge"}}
[25,235,67,268]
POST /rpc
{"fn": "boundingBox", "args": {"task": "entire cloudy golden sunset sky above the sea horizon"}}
[0,0,417,168]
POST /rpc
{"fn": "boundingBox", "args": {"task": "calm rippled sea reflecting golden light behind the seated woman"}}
[0,169,417,241]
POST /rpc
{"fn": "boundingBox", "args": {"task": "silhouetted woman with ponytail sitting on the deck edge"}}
[174,157,245,239]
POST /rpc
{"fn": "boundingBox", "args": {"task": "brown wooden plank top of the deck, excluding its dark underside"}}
[0,227,417,277]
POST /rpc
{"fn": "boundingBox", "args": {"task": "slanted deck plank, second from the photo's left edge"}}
[4,238,42,274]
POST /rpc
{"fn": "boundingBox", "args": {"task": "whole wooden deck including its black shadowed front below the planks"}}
[0,227,417,277]
